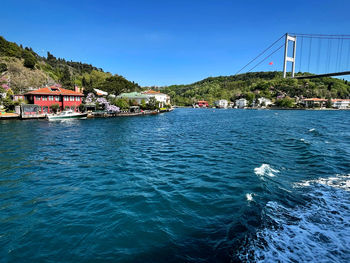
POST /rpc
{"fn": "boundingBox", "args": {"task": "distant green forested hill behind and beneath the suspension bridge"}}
[159,71,350,105]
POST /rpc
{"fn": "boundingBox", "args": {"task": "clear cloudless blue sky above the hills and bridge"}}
[0,0,350,86]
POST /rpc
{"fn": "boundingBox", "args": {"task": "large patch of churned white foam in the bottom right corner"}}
[238,174,350,262]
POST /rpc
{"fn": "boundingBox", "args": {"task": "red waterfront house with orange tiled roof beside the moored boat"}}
[24,86,84,113]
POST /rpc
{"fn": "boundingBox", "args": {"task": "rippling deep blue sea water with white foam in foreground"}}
[0,109,350,262]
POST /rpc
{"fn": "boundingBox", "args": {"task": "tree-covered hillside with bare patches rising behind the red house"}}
[0,36,140,94]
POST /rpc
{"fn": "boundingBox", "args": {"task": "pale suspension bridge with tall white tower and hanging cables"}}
[236,33,350,79]
